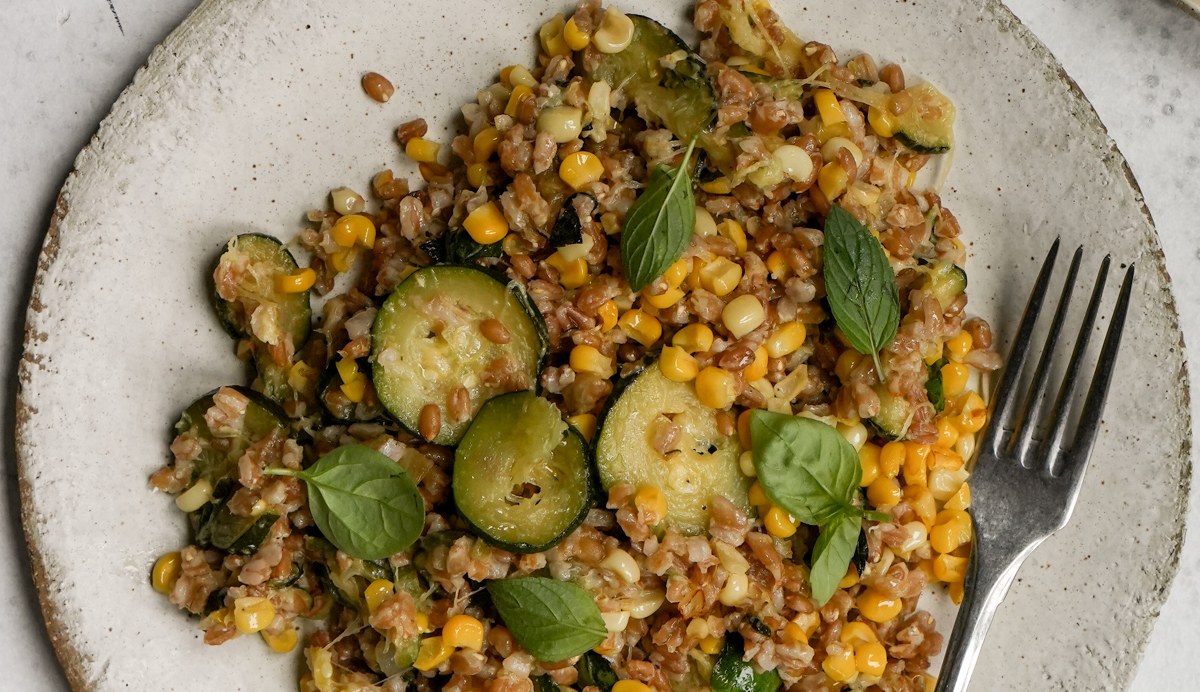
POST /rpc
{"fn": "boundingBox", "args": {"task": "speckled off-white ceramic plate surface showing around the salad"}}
[17,0,1190,692]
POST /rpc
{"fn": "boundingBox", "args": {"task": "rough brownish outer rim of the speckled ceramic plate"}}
[13,0,1200,692]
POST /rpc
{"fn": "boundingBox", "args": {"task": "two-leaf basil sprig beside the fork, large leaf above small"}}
[750,410,892,606]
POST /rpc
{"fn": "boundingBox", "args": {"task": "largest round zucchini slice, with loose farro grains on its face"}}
[371,265,546,445]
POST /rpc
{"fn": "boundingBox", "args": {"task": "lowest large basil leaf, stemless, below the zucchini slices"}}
[487,577,608,663]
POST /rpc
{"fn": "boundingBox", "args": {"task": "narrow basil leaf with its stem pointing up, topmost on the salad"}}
[620,138,696,291]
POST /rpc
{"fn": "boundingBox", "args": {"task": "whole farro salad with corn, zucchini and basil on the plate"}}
[151,0,1001,692]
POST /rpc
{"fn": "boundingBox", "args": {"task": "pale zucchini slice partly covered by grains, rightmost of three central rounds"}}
[595,365,750,534]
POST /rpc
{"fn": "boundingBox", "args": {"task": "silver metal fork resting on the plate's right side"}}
[936,240,1134,692]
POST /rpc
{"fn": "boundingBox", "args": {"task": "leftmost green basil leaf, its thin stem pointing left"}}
[263,445,425,560]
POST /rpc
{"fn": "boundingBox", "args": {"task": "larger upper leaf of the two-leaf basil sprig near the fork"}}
[750,410,863,526]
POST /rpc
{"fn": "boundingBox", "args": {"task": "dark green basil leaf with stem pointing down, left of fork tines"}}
[824,205,900,380]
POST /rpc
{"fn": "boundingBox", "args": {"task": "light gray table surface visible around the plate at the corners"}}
[0,0,1200,692]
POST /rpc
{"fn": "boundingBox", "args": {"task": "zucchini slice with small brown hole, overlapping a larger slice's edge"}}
[452,391,592,553]
